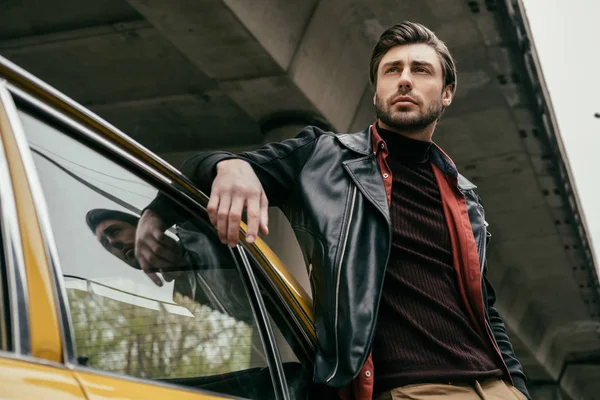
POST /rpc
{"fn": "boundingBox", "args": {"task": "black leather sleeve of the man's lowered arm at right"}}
[484,277,531,399]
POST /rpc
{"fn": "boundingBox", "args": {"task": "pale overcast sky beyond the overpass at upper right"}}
[522,0,600,269]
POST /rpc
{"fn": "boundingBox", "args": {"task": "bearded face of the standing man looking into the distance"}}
[373,43,452,132]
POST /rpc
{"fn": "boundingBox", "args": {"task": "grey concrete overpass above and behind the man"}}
[0,0,600,399]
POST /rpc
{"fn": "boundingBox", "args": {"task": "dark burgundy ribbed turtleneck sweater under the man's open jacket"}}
[373,128,502,394]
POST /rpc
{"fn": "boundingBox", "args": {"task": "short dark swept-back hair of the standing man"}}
[369,21,457,92]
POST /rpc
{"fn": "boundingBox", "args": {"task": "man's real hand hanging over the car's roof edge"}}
[207,160,269,247]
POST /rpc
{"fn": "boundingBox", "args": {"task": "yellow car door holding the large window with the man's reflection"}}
[0,57,298,399]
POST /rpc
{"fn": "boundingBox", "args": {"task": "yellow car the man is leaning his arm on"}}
[0,58,329,400]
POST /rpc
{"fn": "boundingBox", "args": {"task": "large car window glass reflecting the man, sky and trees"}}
[20,111,273,398]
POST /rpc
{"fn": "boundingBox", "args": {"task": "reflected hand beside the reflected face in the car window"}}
[135,210,181,286]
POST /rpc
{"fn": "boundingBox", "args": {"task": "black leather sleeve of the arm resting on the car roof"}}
[145,126,324,224]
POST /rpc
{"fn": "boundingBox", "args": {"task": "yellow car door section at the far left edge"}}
[0,80,86,400]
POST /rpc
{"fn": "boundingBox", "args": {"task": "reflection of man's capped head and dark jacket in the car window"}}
[86,209,252,323]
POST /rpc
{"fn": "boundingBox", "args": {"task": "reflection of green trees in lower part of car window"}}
[68,289,252,378]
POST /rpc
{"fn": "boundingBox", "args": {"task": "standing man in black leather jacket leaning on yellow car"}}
[136,22,529,400]
